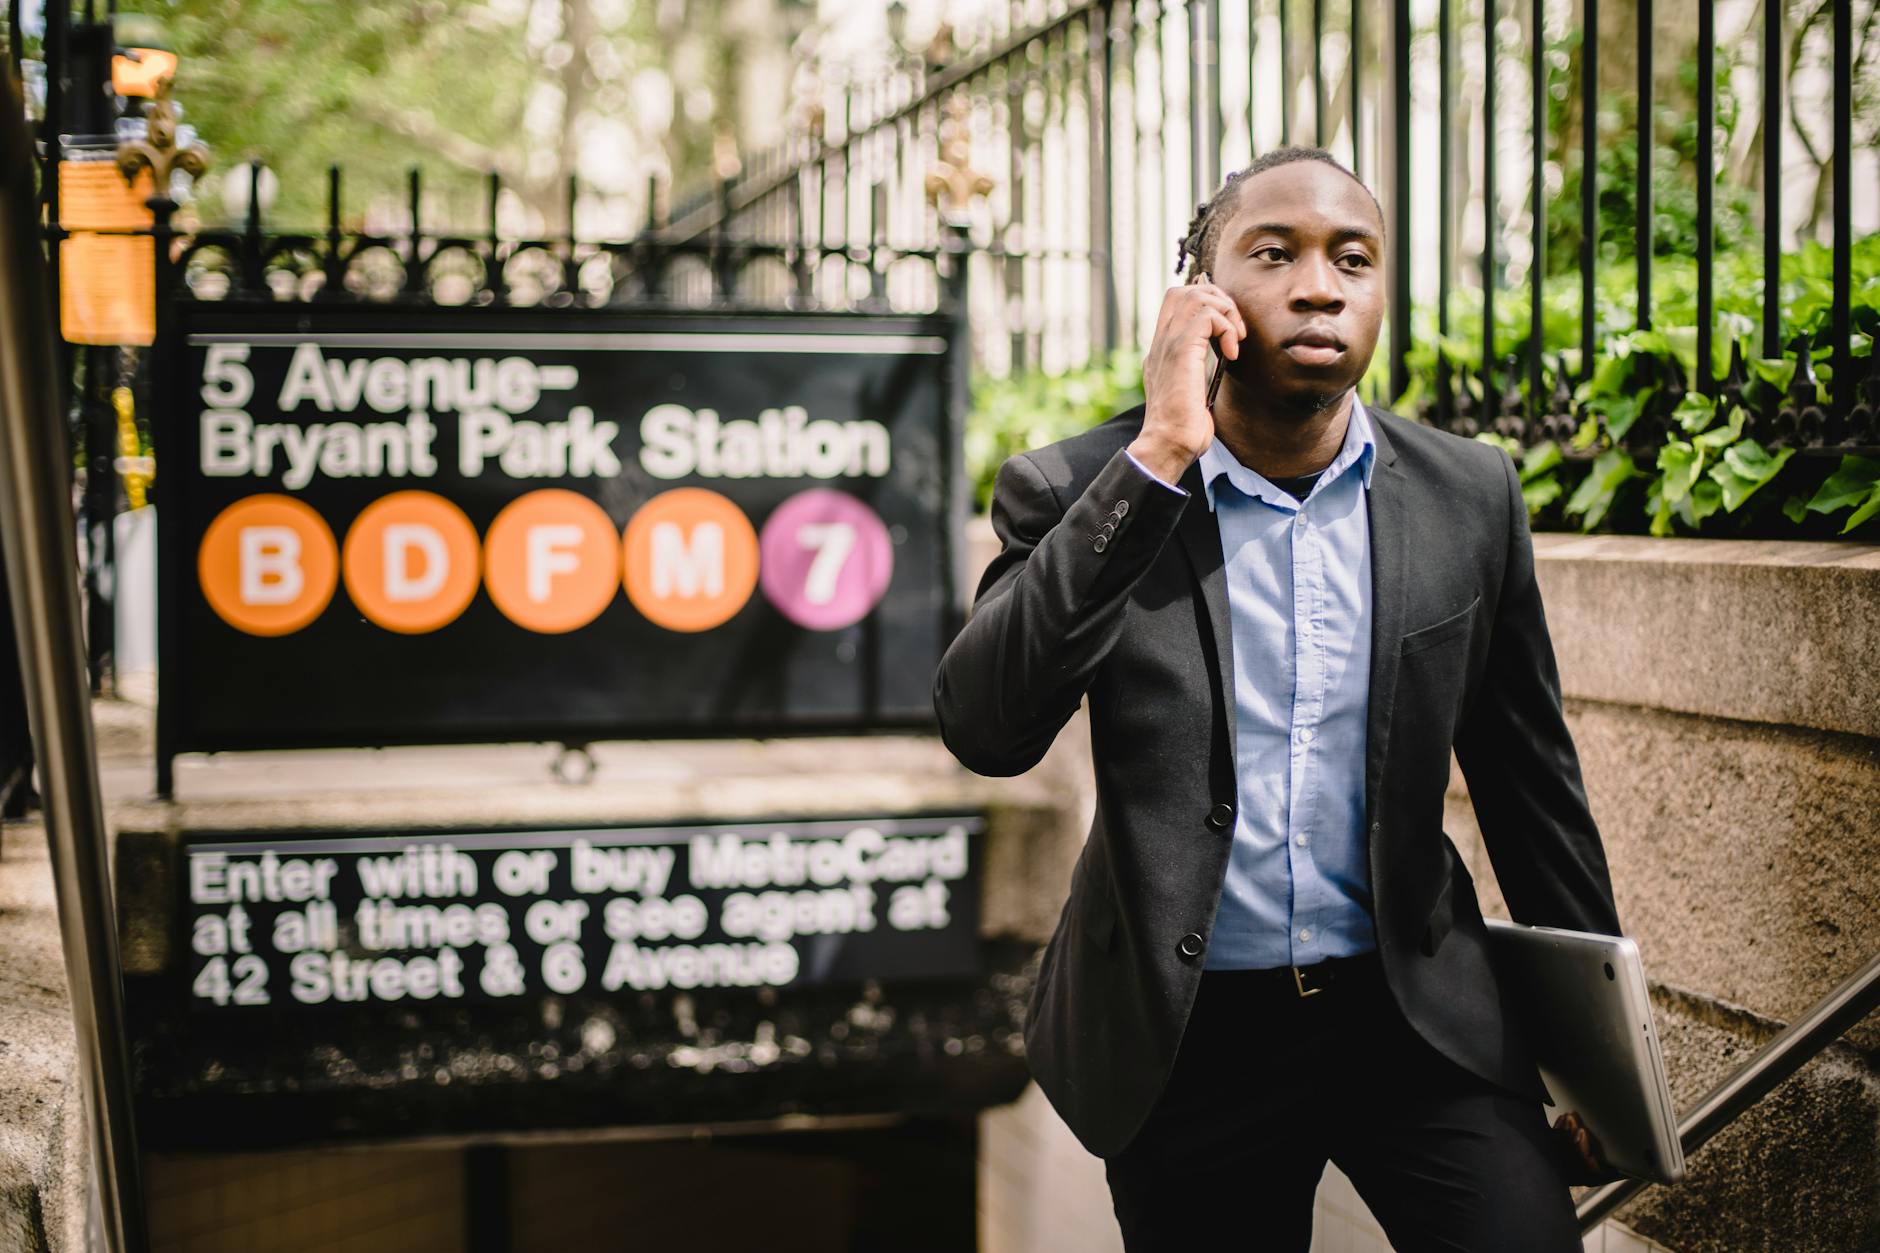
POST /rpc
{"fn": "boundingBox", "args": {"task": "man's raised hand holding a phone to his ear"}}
[1130,275,1246,484]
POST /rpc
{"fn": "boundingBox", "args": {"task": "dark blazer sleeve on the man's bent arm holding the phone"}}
[934,438,1188,775]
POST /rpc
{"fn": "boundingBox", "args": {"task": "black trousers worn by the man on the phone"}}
[1105,954,1583,1253]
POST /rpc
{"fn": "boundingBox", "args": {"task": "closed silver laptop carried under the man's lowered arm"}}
[1485,918,1684,1183]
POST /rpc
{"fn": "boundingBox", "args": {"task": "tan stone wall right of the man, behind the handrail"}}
[1446,534,1880,1253]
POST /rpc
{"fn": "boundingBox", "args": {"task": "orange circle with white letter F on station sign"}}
[483,487,620,636]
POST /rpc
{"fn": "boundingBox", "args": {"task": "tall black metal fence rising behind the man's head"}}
[667,0,1880,457]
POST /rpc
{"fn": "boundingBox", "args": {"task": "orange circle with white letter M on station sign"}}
[622,487,758,632]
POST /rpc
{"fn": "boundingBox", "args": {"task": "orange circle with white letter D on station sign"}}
[340,491,481,636]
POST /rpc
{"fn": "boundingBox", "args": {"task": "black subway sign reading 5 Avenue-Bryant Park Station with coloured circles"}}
[158,303,963,764]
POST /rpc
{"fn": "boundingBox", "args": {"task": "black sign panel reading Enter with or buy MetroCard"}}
[179,815,985,1014]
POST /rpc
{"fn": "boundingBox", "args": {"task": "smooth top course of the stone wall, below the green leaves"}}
[1534,534,1880,736]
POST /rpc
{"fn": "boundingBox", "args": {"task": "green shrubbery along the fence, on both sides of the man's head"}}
[966,233,1880,538]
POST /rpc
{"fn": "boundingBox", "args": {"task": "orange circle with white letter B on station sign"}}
[196,493,340,636]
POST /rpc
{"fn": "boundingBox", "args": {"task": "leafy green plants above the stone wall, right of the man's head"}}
[1391,235,1880,536]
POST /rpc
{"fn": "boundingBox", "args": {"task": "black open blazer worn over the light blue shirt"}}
[934,406,1619,1157]
